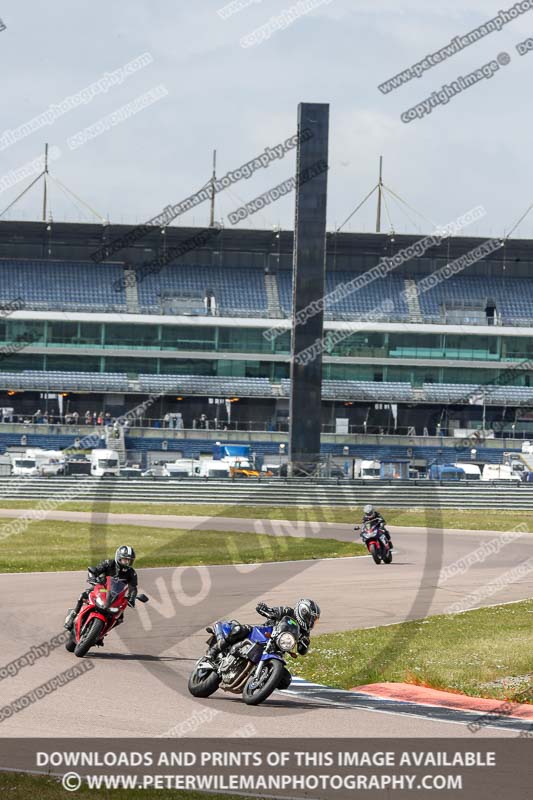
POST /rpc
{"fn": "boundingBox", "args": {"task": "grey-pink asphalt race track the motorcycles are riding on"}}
[0,509,533,737]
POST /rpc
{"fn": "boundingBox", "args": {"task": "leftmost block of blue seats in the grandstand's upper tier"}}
[0,259,126,311]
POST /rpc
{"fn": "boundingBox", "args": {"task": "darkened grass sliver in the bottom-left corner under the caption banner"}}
[0,772,251,800]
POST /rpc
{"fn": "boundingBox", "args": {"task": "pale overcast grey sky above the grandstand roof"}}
[0,0,533,238]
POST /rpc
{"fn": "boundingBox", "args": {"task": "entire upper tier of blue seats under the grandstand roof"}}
[0,259,533,325]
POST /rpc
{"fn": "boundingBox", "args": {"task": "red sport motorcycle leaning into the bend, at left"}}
[65,577,148,658]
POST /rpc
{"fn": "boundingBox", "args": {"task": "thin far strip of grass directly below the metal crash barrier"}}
[1,500,533,531]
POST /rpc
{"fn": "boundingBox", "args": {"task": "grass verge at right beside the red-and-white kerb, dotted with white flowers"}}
[295,600,533,702]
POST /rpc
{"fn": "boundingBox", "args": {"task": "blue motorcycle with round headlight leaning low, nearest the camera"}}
[188,616,300,706]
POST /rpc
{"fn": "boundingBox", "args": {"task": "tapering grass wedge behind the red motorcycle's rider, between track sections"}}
[0,520,367,572]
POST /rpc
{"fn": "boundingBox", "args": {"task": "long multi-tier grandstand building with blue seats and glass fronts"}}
[0,222,533,466]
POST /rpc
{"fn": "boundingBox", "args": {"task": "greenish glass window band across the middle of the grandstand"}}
[0,317,533,386]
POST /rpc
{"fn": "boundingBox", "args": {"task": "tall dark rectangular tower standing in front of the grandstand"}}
[289,103,329,472]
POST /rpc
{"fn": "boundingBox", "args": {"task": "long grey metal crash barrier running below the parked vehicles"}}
[0,477,533,511]
